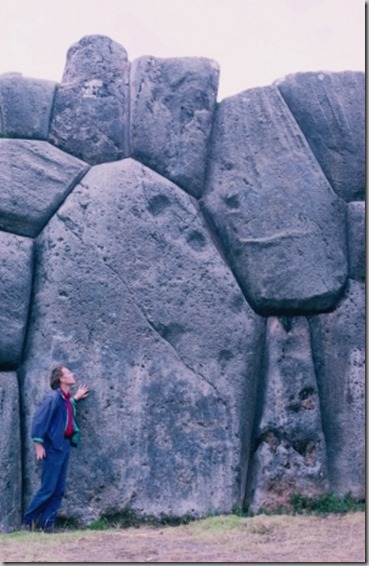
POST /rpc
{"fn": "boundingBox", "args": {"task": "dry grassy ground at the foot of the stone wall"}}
[0,512,365,564]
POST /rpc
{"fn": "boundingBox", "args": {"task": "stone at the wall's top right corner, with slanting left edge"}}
[276,71,365,201]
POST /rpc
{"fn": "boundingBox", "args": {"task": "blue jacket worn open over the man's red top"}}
[31,389,80,450]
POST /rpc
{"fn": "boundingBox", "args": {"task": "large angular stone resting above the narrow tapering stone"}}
[203,86,347,315]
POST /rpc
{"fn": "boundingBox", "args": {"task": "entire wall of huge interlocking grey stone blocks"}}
[0,36,365,531]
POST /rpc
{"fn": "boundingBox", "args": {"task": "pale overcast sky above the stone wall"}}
[0,0,365,100]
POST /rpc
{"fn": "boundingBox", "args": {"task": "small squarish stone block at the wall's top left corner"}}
[0,73,56,140]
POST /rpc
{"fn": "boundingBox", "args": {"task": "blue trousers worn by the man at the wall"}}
[23,439,70,529]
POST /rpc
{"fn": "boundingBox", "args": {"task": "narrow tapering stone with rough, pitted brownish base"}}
[248,317,328,512]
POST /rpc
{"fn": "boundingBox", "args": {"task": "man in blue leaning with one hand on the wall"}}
[23,365,89,532]
